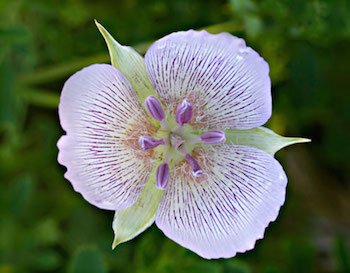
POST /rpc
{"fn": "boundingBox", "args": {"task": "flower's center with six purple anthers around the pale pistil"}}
[139,96,226,190]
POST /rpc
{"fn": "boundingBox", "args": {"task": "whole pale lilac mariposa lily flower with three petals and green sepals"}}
[58,23,308,259]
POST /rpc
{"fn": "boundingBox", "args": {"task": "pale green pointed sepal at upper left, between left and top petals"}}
[95,21,155,103]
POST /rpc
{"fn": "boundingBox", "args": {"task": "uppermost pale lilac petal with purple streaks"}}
[145,30,271,129]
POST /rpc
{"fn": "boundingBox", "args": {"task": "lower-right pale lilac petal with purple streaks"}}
[156,145,287,259]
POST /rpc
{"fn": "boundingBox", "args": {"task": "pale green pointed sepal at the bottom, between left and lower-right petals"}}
[112,164,163,249]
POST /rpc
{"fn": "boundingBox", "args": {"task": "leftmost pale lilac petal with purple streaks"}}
[58,64,155,210]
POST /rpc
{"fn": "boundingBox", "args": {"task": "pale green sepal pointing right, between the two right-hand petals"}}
[225,127,311,155]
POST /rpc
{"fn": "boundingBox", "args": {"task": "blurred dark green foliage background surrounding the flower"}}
[0,0,350,273]
